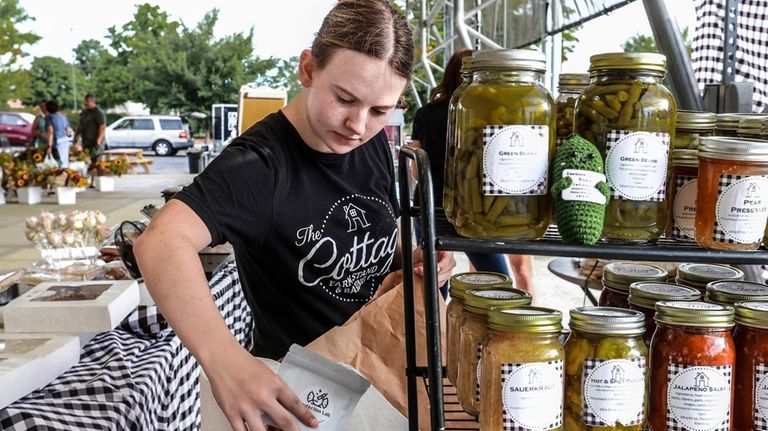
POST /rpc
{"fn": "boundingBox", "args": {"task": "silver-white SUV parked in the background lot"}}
[104,115,194,156]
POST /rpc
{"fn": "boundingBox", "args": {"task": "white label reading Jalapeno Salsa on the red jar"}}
[667,364,733,431]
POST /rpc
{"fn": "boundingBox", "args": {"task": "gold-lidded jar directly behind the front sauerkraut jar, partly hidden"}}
[456,288,531,416]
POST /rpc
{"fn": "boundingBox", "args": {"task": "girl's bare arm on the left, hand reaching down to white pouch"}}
[134,199,318,431]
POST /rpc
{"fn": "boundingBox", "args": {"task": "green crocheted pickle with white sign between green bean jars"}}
[550,133,610,244]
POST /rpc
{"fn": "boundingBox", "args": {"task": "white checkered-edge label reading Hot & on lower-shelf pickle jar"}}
[582,358,646,427]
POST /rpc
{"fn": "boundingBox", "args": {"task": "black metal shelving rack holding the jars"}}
[398,147,768,431]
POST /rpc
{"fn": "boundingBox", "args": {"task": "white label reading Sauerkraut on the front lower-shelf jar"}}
[501,361,563,431]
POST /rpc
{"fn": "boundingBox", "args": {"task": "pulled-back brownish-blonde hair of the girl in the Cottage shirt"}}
[312,0,413,80]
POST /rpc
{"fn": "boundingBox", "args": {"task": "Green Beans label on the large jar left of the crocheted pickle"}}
[483,126,549,196]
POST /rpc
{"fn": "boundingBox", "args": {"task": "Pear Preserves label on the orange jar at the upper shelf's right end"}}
[712,175,768,244]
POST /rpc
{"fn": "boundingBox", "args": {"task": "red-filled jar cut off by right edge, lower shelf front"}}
[733,302,768,431]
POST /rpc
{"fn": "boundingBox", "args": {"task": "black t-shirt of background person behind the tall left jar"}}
[411,100,448,207]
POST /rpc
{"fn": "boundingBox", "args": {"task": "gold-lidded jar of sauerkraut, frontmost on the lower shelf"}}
[480,307,565,431]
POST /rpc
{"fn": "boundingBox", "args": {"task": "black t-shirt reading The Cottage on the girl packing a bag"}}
[175,112,397,358]
